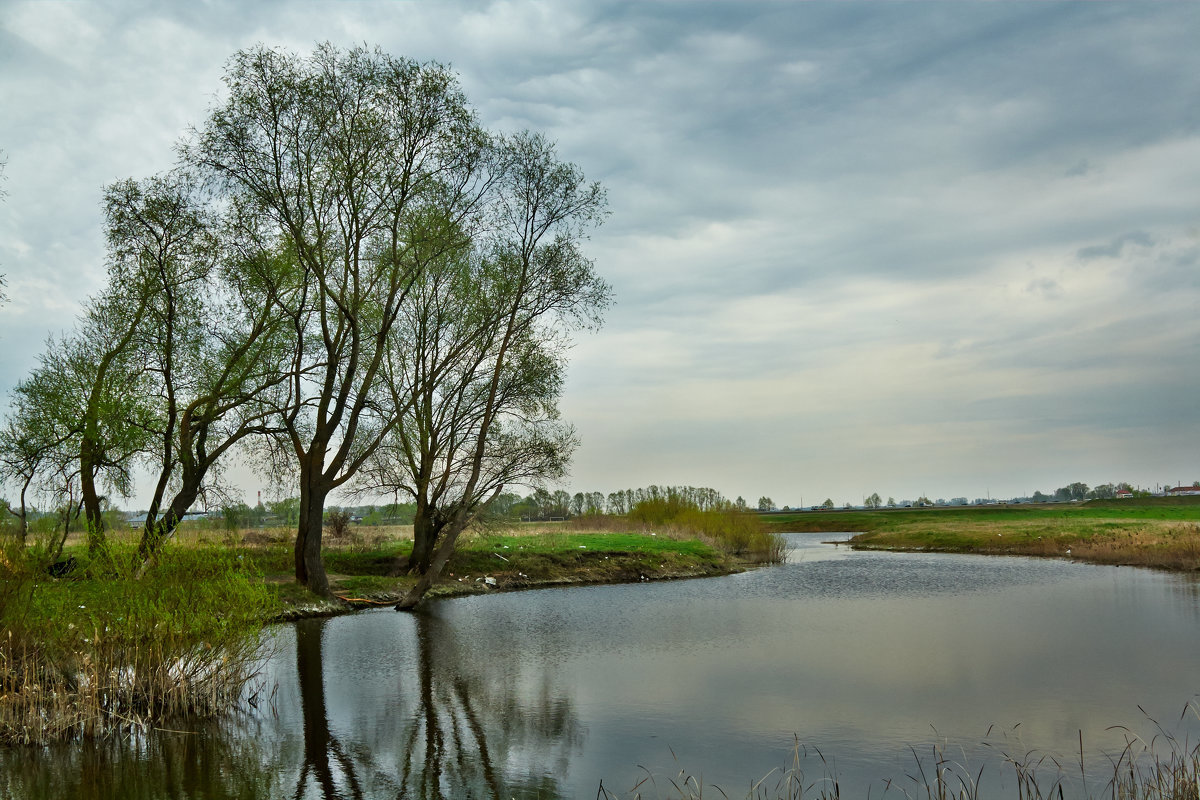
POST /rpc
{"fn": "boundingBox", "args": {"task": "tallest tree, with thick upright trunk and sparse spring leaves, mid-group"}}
[185,44,490,594]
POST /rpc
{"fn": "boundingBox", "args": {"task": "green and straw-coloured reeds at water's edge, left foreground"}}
[0,541,270,744]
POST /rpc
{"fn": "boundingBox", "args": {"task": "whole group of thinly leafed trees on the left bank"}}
[0,44,611,607]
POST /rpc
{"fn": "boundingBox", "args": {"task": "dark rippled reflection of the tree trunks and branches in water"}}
[293,613,581,800]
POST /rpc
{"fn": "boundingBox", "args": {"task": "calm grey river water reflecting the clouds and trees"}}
[0,534,1200,800]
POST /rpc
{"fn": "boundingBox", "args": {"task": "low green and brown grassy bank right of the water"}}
[767,498,1200,571]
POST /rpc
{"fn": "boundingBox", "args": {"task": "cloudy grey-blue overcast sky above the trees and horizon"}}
[0,0,1200,506]
